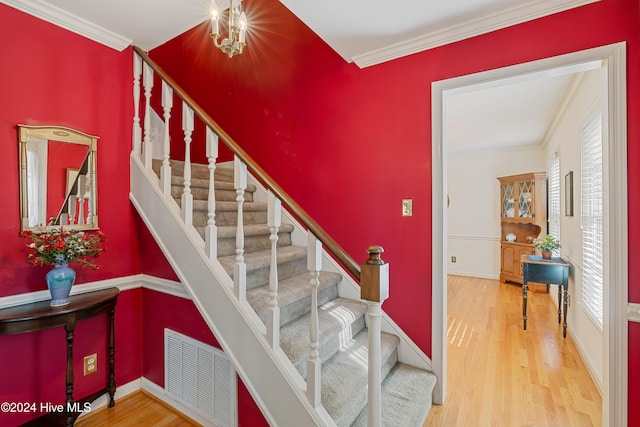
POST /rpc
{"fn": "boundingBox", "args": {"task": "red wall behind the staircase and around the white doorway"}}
[151,0,640,425]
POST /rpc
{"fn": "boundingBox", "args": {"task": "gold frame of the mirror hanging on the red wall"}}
[16,124,100,233]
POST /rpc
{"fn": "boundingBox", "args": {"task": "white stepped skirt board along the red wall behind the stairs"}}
[246,172,433,372]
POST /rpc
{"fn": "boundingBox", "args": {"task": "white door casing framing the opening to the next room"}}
[432,43,628,425]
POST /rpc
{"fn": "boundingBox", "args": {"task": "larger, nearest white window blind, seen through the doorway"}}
[581,112,604,329]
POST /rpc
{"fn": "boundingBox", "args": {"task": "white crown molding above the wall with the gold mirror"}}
[0,0,132,51]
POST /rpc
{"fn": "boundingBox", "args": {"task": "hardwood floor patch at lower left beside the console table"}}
[74,391,200,427]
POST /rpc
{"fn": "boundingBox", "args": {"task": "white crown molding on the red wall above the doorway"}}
[352,0,600,68]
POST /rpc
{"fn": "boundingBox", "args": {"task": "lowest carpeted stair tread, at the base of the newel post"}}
[352,363,436,427]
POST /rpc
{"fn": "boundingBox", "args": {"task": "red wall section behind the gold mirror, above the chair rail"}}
[0,5,140,296]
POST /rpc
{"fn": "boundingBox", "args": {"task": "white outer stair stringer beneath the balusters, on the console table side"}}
[129,154,335,427]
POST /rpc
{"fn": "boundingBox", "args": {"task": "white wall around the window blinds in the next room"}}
[546,69,604,390]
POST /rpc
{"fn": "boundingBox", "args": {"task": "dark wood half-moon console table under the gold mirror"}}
[0,288,120,427]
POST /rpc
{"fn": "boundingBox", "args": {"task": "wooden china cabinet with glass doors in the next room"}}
[498,172,547,284]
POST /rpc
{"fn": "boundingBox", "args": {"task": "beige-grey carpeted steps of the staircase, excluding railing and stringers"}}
[153,160,435,426]
